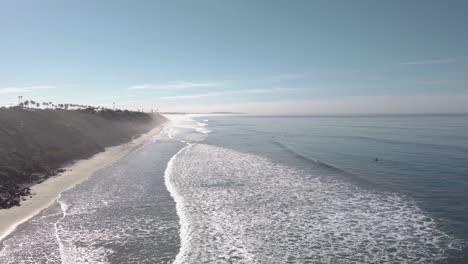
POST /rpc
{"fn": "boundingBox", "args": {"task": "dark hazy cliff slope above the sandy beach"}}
[0,108,166,208]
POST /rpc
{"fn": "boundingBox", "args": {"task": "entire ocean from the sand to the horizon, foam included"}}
[0,115,468,263]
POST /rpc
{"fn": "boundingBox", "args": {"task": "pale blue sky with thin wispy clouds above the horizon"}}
[0,0,468,115]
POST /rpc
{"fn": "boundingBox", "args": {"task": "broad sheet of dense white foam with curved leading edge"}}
[166,144,460,263]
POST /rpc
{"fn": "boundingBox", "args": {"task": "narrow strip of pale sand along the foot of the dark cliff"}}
[0,125,163,242]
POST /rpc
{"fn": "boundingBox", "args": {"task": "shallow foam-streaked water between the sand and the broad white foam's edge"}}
[0,137,178,264]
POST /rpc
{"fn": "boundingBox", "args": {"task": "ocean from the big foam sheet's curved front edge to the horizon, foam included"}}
[169,115,468,263]
